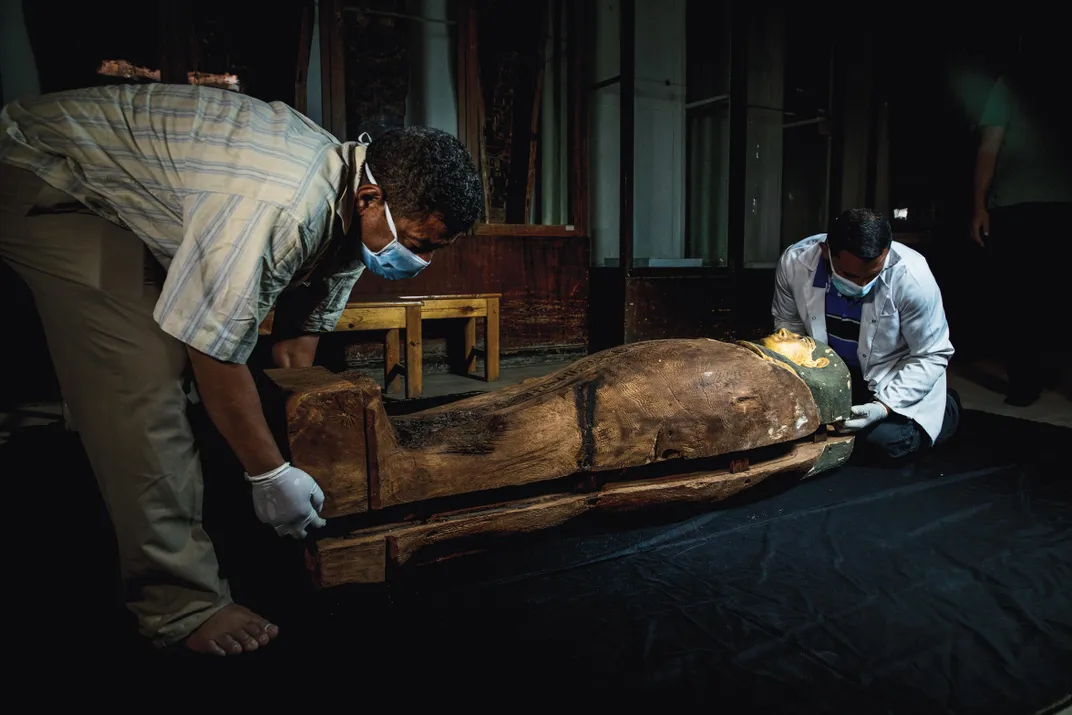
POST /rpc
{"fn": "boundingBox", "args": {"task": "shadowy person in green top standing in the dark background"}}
[971,30,1072,406]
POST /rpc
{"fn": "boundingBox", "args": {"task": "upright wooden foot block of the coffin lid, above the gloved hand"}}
[265,367,370,518]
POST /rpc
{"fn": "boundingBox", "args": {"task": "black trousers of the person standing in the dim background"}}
[983,203,1072,397]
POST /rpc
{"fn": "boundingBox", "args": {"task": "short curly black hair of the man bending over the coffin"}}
[364,126,483,236]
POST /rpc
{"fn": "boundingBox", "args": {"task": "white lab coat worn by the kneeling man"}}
[771,234,953,443]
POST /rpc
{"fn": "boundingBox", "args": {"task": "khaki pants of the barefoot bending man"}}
[0,165,230,645]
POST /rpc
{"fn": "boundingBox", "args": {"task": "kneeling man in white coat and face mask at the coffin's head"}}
[771,209,961,458]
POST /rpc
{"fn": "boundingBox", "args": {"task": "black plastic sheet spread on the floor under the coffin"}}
[0,411,1072,715]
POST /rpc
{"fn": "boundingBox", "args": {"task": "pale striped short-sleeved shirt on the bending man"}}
[0,85,364,362]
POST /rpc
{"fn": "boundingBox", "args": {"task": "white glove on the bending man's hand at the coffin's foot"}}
[245,462,328,538]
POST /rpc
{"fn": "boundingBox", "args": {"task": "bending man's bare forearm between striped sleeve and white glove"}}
[187,347,284,475]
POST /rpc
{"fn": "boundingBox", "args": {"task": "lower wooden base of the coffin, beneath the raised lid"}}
[315,436,852,587]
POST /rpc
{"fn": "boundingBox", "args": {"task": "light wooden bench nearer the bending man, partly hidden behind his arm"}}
[257,296,423,398]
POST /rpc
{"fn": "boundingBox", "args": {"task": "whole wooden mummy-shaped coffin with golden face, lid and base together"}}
[268,331,852,585]
